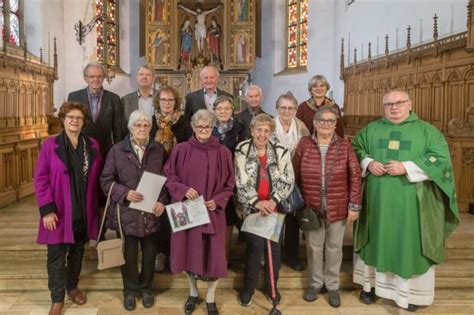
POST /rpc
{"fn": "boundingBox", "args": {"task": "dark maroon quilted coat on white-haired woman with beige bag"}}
[100,136,166,237]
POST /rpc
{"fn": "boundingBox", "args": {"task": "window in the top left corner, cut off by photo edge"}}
[0,0,23,46]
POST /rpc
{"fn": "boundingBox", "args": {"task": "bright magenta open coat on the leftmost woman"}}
[34,133,102,245]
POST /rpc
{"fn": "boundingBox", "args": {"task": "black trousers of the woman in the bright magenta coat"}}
[46,232,86,303]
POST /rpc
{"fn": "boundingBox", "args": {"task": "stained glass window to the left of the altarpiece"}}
[96,0,119,66]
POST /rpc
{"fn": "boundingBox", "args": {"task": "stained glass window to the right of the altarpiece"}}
[286,0,308,69]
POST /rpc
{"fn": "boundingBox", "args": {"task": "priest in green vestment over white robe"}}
[353,90,459,311]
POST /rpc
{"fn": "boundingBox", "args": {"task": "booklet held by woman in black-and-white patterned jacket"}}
[241,212,285,242]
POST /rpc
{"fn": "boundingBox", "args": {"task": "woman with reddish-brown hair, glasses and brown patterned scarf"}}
[150,85,187,272]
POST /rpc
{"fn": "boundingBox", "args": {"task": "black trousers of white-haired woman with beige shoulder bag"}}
[121,233,157,297]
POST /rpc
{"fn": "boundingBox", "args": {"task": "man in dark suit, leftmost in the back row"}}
[68,63,124,158]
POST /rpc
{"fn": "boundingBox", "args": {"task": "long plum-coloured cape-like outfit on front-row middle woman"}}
[163,136,235,278]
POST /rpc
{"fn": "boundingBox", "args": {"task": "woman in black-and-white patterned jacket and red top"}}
[235,114,294,306]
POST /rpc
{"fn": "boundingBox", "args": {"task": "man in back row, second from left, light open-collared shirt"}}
[122,64,156,124]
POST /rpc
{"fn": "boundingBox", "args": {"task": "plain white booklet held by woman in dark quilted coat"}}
[129,171,166,213]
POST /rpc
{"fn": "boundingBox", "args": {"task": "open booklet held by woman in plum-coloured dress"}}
[166,196,211,233]
